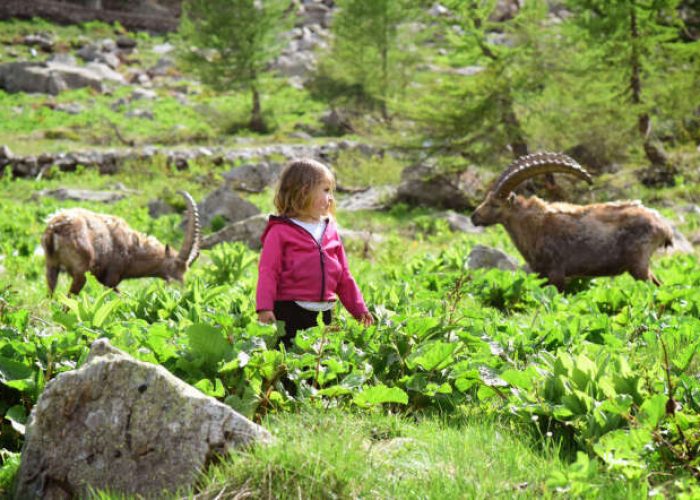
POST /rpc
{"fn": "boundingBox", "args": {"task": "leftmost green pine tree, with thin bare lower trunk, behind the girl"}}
[179,0,289,132]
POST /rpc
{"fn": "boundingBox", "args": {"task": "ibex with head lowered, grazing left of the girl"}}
[41,191,199,294]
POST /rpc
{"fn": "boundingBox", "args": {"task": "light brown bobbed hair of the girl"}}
[275,158,335,217]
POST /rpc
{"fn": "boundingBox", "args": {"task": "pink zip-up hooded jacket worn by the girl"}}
[256,215,367,318]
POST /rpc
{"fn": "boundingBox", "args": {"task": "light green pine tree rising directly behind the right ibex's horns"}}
[413,0,547,165]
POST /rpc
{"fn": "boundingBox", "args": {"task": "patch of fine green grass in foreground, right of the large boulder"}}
[197,410,563,499]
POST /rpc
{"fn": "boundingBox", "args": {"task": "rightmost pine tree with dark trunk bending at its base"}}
[565,0,699,183]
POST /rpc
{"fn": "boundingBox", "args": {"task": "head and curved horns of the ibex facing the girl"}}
[471,153,593,226]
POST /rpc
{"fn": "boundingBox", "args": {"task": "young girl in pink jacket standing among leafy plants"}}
[256,159,372,347]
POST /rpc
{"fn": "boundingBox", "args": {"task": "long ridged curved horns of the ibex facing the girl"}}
[491,153,593,198]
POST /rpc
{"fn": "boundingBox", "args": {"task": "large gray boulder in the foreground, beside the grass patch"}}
[15,339,270,499]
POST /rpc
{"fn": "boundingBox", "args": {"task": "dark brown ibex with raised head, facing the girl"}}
[471,153,673,290]
